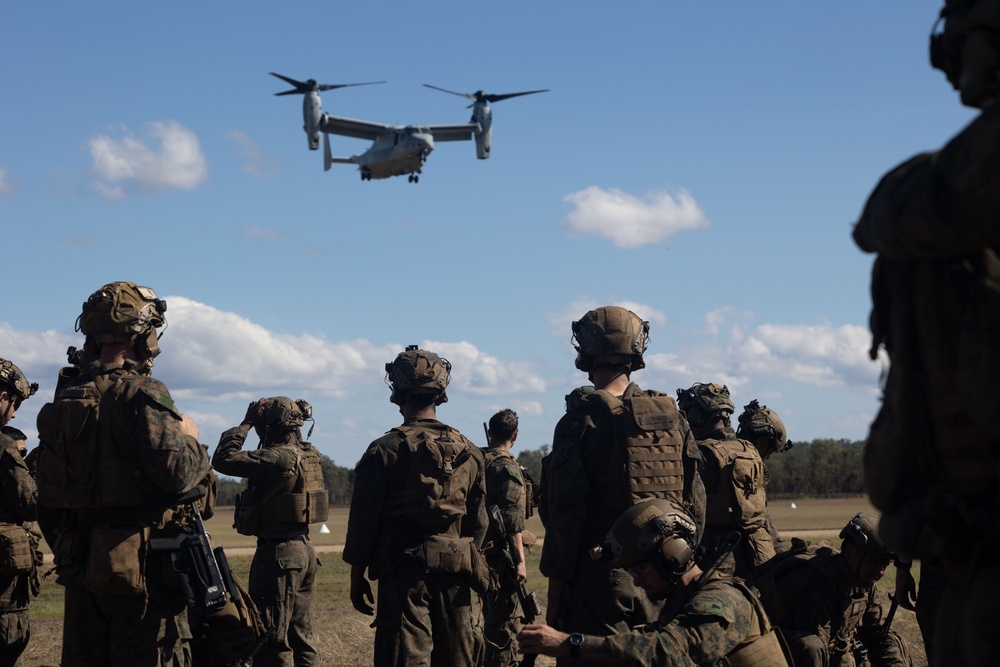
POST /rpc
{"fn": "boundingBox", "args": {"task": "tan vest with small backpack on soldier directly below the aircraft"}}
[384,423,481,537]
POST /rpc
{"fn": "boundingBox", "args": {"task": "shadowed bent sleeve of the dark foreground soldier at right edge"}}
[854,107,1000,260]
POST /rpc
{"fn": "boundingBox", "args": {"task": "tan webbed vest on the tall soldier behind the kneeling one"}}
[581,389,684,508]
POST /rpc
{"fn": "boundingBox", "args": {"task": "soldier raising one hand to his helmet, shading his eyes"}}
[212,396,329,667]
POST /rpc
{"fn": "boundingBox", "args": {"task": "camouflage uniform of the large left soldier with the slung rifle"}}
[39,362,209,667]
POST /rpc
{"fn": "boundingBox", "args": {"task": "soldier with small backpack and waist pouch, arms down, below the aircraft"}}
[344,345,489,667]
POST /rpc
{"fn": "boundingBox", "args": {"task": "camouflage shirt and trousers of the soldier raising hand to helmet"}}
[212,426,320,667]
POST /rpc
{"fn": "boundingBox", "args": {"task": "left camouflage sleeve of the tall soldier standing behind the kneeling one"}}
[539,410,594,581]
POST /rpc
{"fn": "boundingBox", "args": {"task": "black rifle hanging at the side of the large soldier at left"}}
[149,485,229,614]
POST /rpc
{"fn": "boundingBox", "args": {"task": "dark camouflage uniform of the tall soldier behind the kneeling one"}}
[540,383,705,664]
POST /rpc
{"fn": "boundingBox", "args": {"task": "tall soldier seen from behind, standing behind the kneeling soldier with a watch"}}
[540,306,705,664]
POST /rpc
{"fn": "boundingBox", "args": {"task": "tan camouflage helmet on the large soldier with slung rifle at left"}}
[76,282,167,359]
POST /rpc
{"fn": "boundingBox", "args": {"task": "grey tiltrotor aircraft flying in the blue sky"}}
[271,72,548,183]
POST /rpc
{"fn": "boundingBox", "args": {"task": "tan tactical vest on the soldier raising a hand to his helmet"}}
[259,443,330,533]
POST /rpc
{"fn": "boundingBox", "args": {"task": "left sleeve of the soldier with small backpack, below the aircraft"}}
[343,434,398,567]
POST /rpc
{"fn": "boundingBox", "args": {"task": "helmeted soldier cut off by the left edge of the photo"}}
[0,359,41,667]
